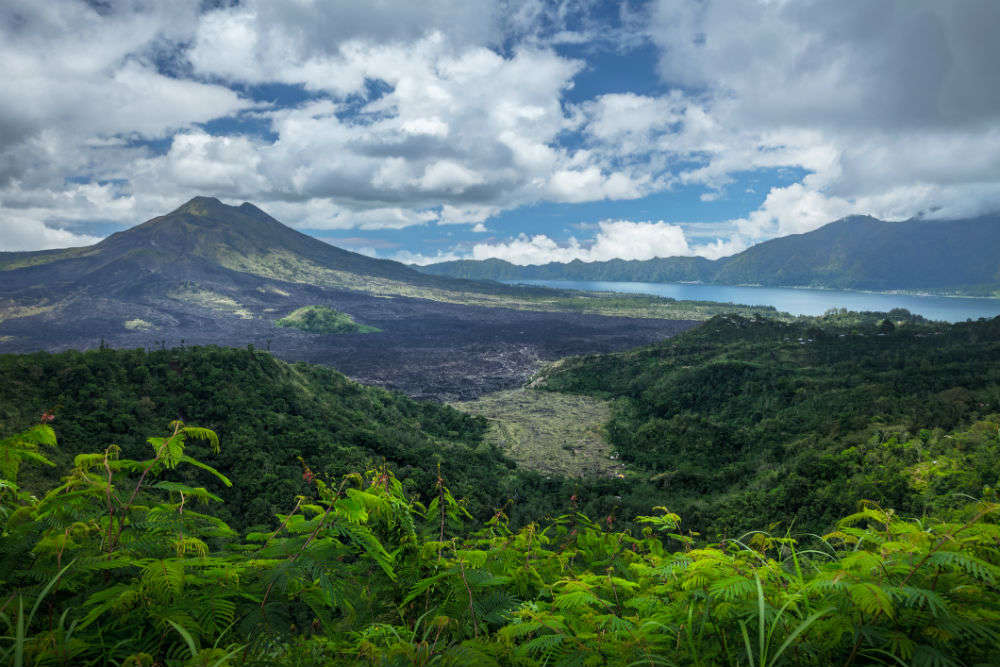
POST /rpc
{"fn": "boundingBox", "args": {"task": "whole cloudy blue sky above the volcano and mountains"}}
[0,0,1000,264]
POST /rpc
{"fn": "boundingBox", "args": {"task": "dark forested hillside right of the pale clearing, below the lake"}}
[540,311,1000,537]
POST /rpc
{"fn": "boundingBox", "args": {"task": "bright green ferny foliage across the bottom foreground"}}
[0,425,1000,667]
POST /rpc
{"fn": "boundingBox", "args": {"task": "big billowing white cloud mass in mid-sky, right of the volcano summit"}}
[133,28,653,219]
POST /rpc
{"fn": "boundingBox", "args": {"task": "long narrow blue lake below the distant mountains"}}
[505,280,1000,322]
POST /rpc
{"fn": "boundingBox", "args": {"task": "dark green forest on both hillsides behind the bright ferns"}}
[0,311,1000,536]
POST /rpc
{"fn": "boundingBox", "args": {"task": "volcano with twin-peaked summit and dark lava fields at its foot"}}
[0,197,692,400]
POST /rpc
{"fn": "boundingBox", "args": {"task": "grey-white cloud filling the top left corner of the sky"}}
[0,0,249,153]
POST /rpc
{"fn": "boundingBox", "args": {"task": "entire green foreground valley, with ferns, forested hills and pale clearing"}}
[0,312,1000,667]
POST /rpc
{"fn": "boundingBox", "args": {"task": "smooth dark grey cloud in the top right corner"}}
[648,0,1000,131]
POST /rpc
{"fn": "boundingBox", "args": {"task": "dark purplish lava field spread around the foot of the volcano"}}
[0,282,697,401]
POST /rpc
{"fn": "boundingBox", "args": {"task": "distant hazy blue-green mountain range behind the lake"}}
[416,215,1000,296]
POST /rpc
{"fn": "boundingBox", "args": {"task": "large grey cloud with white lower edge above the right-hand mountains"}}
[636,0,1000,239]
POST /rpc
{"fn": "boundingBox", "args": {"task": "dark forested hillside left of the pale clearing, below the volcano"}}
[0,347,530,526]
